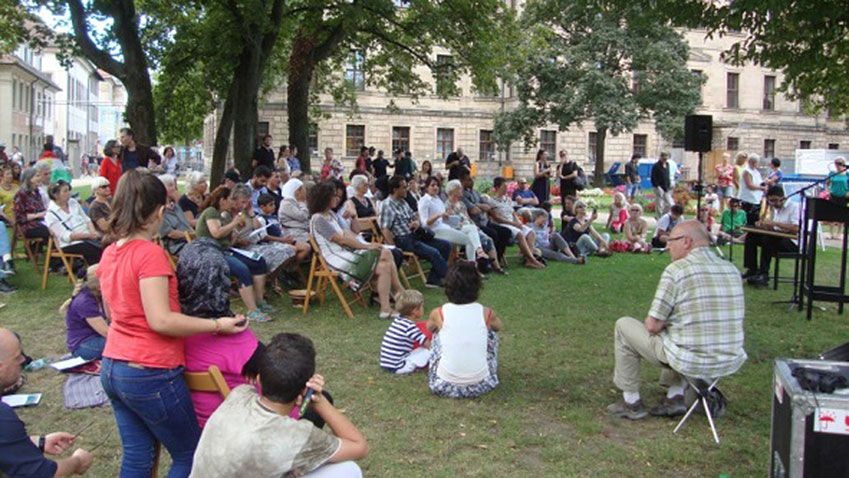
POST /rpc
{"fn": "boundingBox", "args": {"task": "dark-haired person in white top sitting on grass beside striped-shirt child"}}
[427,262,501,398]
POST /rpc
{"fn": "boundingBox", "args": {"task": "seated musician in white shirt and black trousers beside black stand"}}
[743,186,799,285]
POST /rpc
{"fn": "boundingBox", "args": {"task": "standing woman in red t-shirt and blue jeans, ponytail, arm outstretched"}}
[97,170,247,478]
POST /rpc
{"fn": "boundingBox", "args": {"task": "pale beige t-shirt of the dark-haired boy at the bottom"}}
[190,385,342,478]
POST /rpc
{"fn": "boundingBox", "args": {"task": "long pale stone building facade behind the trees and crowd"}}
[204,30,849,179]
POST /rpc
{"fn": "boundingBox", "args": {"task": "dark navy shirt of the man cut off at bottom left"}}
[0,402,57,478]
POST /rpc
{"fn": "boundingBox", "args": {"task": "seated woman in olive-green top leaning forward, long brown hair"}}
[197,186,271,323]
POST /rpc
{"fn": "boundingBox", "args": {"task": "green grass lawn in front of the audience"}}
[0,222,849,478]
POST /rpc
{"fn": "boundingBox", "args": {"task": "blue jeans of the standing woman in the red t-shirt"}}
[100,358,200,478]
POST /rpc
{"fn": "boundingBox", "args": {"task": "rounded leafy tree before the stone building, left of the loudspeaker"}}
[494,0,704,183]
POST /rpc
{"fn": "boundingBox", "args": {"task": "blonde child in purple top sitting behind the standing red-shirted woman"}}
[59,264,109,360]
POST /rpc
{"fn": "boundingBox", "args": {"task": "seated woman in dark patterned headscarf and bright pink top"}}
[177,237,262,428]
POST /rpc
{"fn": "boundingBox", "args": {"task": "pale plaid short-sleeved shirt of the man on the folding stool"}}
[649,247,747,379]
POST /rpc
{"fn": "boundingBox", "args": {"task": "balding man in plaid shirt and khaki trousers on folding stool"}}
[607,220,746,420]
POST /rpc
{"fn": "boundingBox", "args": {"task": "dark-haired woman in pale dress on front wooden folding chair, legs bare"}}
[307,181,404,319]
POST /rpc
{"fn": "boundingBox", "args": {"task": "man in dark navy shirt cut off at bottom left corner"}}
[0,328,92,478]
